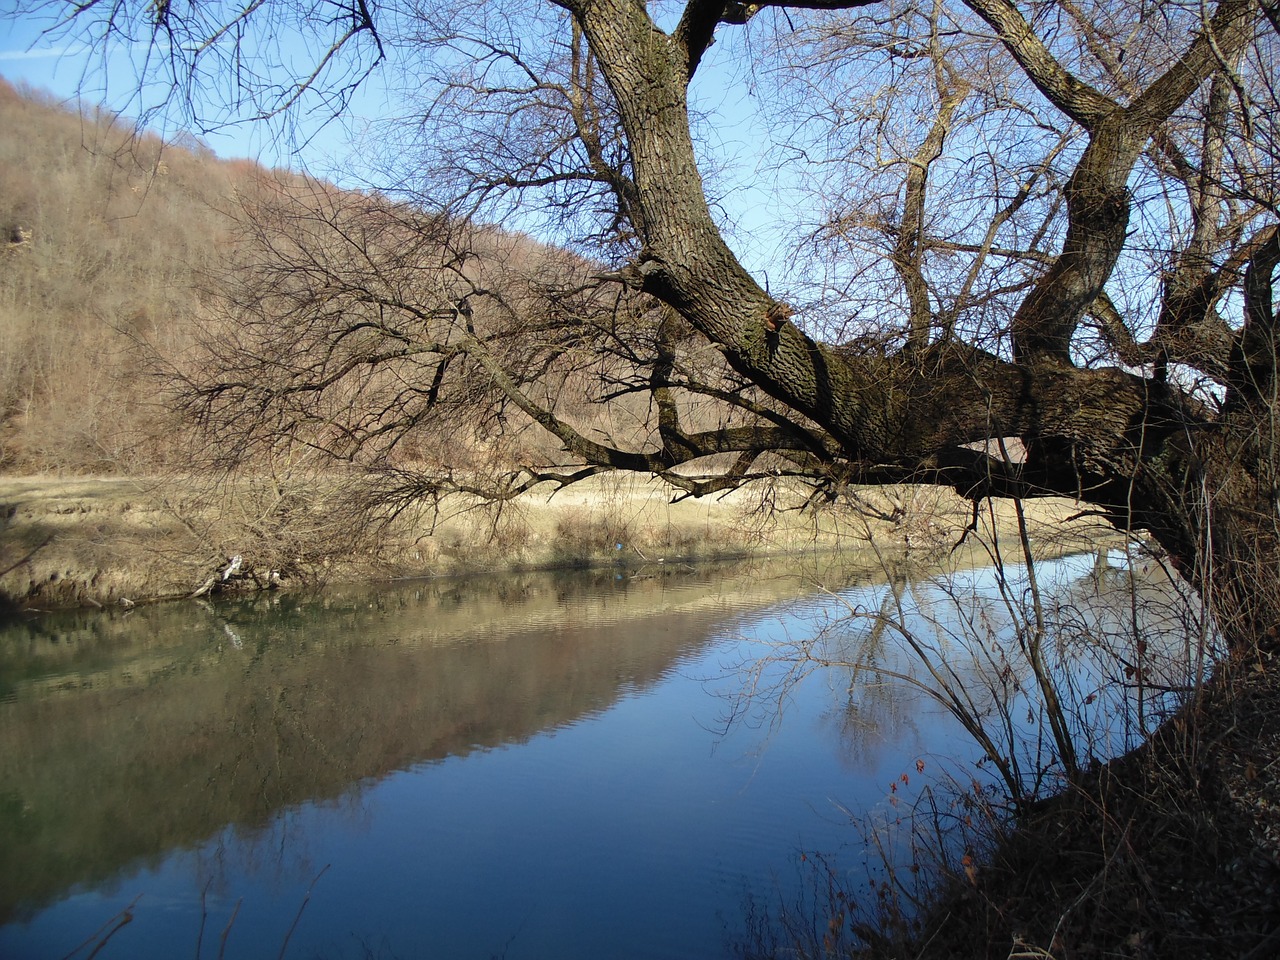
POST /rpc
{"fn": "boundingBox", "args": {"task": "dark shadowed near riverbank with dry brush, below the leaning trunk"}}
[901,637,1280,960]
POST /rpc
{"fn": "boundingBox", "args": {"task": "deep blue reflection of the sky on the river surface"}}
[0,557,1203,960]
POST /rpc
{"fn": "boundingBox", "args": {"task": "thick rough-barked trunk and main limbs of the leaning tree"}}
[573,0,1280,645]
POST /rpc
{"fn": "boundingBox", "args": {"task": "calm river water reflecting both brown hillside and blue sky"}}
[0,557,1185,960]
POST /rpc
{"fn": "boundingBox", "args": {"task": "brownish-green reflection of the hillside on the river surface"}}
[0,563,793,919]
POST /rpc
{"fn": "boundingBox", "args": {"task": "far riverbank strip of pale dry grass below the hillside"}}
[0,476,1115,609]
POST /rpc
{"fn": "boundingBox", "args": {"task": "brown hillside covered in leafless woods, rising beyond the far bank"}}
[0,81,680,476]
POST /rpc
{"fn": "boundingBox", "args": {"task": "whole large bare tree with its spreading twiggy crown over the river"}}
[24,0,1280,645]
